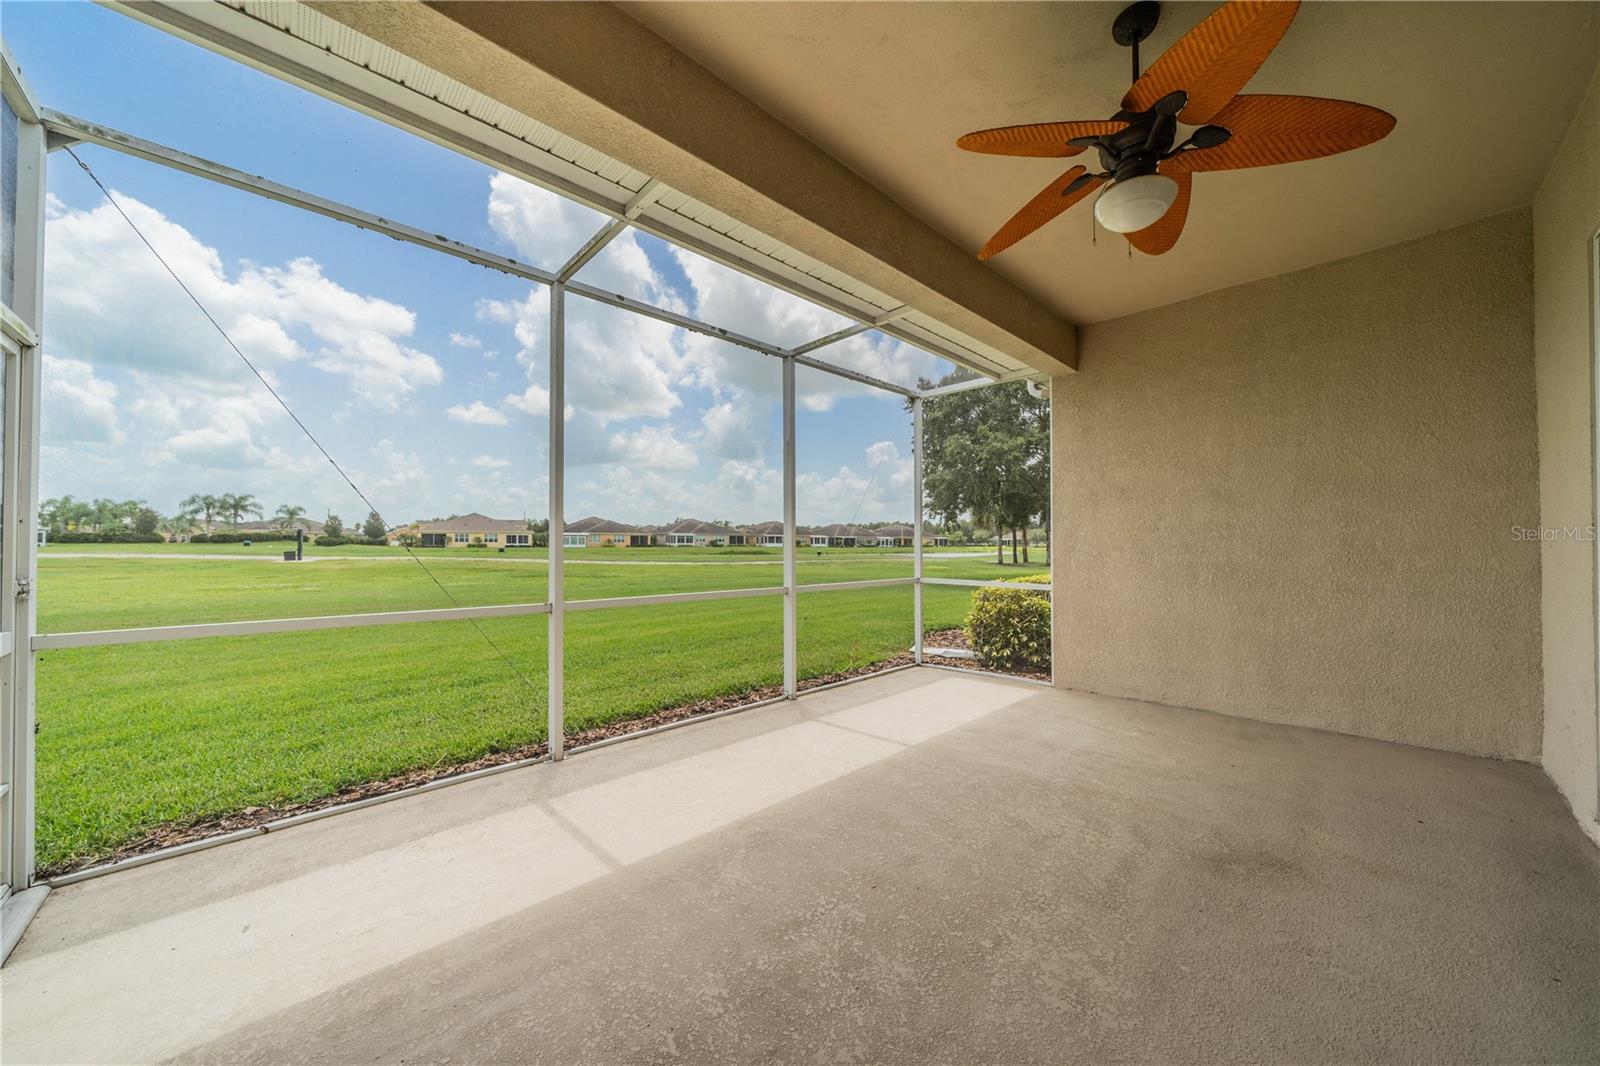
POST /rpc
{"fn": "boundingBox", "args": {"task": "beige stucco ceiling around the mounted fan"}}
[624,2,1600,322]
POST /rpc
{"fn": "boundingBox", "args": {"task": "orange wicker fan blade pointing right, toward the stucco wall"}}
[1162,96,1395,176]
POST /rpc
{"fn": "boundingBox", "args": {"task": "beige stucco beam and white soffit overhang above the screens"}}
[114,0,1077,379]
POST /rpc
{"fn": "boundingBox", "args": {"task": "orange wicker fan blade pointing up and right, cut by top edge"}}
[1122,0,1299,126]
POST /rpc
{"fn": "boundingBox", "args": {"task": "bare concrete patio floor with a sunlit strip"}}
[0,671,1600,1063]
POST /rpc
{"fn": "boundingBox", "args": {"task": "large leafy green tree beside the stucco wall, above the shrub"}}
[922,375,1050,563]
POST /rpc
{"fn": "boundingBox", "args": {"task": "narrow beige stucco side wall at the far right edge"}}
[1533,62,1600,840]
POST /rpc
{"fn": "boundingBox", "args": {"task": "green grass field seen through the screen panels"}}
[37,544,1046,869]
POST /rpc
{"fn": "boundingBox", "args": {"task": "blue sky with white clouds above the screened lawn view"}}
[5,2,950,523]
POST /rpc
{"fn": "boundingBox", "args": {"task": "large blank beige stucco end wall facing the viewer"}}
[1053,208,1541,759]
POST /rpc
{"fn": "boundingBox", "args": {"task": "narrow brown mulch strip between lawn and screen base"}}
[38,653,934,877]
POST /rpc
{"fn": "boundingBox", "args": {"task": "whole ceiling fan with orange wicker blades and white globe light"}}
[955,0,1395,259]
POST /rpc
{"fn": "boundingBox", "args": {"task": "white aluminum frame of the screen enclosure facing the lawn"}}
[0,54,1050,906]
